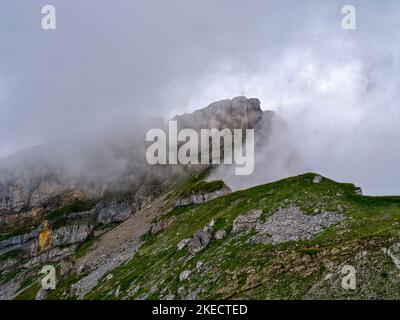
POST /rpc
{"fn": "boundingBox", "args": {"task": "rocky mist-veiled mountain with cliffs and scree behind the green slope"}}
[0,97,284,298]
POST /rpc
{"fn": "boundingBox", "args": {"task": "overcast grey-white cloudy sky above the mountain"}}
[0,0,400,194]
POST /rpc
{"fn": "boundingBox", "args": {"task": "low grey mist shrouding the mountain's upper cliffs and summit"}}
[0,97,301,225]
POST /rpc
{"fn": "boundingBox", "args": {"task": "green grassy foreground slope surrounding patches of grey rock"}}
[18,174,400,299]
